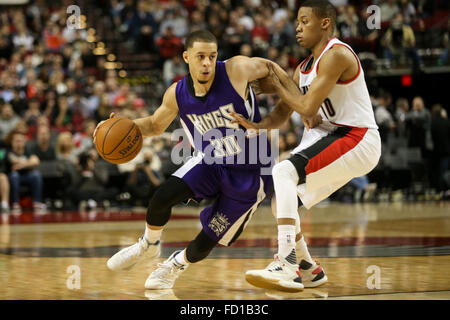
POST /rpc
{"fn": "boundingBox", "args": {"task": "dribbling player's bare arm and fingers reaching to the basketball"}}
[92,83,178,143]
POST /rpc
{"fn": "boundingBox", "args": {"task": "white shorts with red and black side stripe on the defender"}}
[290,125,381,209]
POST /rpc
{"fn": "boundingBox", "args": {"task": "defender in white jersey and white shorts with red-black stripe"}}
[235,0,381,291]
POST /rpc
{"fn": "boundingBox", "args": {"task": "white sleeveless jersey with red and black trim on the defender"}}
[299,37,378,129]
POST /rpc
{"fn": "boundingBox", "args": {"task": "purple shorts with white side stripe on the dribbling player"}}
[173,157,273,246]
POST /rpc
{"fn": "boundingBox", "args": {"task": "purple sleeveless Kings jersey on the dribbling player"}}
[176,61,271,169]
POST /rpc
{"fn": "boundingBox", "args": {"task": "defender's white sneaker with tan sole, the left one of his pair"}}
[245,254,304,292]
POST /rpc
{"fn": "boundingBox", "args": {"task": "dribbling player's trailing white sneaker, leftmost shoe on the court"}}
[106,236,161,271]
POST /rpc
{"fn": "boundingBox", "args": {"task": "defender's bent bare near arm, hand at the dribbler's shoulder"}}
[268,48,355,118]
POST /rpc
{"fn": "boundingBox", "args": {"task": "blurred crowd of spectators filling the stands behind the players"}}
[0,0,450,212]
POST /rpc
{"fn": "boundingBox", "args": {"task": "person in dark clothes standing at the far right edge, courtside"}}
[431,104,450,191]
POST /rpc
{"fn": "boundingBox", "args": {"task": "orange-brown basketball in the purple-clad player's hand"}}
[95,116,142,164]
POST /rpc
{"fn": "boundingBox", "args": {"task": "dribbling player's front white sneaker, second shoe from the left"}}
[145,250,189,290]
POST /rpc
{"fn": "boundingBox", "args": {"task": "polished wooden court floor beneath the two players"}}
[0,202,450,300]
